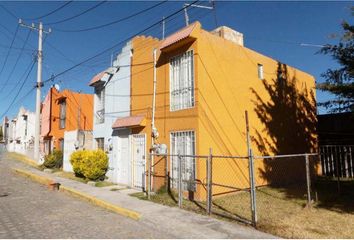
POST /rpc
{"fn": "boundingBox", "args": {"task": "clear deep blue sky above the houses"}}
[0,1,353,117]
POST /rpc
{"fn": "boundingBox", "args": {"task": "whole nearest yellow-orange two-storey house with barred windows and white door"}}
[91,22,317,199]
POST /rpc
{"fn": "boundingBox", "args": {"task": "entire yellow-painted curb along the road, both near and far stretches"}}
[12,168,141,220]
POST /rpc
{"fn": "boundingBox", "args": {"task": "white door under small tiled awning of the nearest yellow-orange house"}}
[132,134,146,188]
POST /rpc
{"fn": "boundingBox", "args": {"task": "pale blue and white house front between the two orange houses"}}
[89,42,132,185]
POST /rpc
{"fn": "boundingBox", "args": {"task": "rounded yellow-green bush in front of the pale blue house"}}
[70,149,108,180]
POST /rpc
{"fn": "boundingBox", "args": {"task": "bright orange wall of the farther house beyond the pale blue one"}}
[48,88,93,149]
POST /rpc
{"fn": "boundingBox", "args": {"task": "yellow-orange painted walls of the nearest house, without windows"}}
[131,22,316,199]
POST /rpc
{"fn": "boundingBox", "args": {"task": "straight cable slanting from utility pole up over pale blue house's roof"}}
[43,0,199,83]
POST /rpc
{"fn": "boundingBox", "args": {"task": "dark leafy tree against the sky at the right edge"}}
[317,7,354,112]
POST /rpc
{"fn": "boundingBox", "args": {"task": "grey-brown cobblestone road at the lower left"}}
[0,153,173,238]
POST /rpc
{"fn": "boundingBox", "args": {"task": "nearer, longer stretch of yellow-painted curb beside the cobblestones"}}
[59,185,141,220]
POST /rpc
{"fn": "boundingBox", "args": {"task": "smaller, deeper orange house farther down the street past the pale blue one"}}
[41,87,93,154]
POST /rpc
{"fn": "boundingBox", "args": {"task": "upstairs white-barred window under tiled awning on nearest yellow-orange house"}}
[170,50,195,111]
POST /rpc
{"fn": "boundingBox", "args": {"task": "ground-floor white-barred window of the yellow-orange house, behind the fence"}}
[170,130,197,192]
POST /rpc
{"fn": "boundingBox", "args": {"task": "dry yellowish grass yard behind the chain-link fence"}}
[130,182,354,238]
